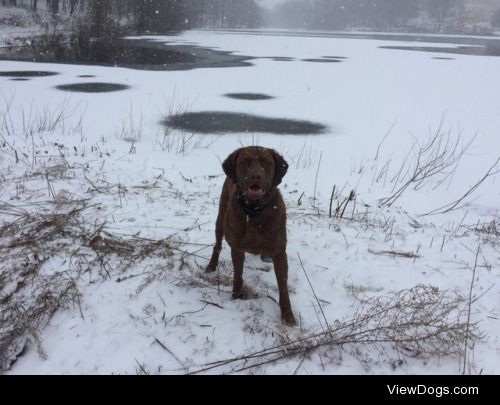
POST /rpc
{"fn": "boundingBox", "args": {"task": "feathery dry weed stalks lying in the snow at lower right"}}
[190,285,482,374]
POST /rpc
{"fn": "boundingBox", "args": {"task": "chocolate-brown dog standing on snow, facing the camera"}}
[207,146,295,325]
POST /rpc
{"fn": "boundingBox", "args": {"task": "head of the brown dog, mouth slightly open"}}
[222,146,288,200]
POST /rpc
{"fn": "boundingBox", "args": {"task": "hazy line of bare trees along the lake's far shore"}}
[0,0,500,35]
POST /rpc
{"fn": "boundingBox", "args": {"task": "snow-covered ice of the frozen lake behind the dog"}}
[0,31,500,211]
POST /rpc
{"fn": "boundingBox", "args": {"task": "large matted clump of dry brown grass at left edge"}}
[0,198,175,371]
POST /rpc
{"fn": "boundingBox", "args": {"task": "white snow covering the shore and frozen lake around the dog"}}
[0,32,500,374]
